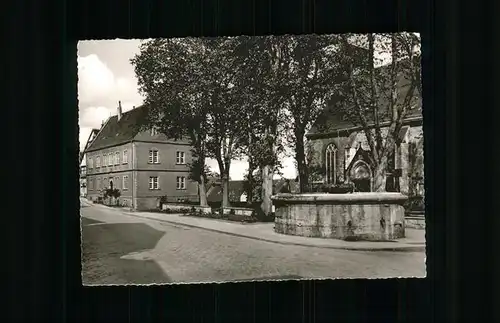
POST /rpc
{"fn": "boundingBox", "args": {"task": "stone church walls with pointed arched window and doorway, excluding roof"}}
[308,117,424,196]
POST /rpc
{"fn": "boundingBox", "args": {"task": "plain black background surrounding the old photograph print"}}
[1,0,492,322]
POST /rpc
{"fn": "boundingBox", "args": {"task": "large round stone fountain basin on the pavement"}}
[272,192,407,241]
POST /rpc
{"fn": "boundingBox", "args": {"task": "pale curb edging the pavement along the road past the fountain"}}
[119,213,425,252]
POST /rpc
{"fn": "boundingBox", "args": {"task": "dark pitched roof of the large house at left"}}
[86,106,148,151]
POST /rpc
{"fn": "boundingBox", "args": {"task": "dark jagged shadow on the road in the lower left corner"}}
[82,223,172,285]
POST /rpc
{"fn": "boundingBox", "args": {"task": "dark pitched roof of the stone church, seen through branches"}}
[307,62,422,136]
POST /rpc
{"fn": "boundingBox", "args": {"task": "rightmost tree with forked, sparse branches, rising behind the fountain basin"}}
[335,33,421,192]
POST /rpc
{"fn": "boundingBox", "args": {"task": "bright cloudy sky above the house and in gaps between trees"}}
[78,34,418,180]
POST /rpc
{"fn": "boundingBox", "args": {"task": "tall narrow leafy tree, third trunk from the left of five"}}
[234,37,290,215]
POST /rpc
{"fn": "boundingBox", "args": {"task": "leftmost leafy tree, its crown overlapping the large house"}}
[131,38,215,206]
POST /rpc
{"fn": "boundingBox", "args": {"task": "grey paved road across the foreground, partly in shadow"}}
[81,206,425,284]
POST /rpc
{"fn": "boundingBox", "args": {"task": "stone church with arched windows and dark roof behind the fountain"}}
[306,63,424,228]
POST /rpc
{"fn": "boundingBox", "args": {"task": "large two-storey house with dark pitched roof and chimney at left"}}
[85,105,199,210]
